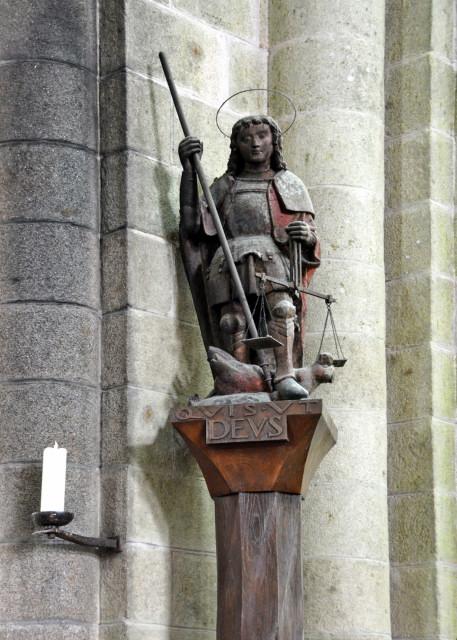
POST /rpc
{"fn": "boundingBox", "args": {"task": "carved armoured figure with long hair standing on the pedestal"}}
[179,116,324,399]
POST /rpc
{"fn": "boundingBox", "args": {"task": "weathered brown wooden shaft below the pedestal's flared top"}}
[215,492,303,640]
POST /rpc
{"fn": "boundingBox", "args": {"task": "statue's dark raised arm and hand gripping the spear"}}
[178,136,202,236]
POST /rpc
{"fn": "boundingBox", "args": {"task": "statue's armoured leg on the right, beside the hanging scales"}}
[270,292,309,400]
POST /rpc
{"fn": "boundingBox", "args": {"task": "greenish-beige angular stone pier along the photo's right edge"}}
[385,0,457,638]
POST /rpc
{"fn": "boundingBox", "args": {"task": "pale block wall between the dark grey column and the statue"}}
[100,0,267,640]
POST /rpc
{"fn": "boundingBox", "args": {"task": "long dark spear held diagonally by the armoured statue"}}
[159,51,272,390]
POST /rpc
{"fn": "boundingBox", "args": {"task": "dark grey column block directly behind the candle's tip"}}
[0,381,100,465]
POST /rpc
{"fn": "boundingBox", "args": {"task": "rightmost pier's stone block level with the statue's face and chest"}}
[386,131,452,209]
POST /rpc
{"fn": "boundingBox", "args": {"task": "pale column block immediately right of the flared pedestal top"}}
[313,408,387,487]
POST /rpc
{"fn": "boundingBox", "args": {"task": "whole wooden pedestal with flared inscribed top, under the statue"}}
[170,400,336,640]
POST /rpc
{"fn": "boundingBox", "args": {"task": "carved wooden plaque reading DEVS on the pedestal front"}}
[206,402,289,444]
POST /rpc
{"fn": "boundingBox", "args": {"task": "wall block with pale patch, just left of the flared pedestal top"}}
[102,388,196,478]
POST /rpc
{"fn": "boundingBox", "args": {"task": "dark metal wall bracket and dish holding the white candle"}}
[32,511,122,553]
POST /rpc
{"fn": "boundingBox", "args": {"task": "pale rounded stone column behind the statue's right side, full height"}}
[270,0,390,640]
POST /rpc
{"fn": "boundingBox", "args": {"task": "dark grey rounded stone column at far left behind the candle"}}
[0,0,100,640]
